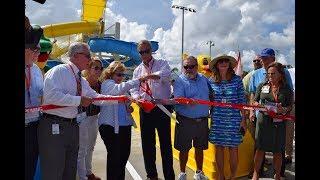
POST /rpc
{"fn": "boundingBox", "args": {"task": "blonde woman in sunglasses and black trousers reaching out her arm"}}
[98,61,154,180]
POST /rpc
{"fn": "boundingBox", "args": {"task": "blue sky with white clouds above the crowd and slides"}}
[26,0,295,71]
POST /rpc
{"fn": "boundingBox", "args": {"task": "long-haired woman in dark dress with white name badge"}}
[252,62,293,180]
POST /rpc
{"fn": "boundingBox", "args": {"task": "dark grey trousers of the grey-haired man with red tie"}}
[38,114,79,180]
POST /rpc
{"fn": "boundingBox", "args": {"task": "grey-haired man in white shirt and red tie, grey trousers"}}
[38,42,114,180]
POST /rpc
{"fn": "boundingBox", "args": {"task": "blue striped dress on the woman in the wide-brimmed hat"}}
[209,75,246,147]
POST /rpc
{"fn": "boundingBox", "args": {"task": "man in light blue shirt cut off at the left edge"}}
[24,26,43,180]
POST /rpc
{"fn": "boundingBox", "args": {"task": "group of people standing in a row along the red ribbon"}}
[25,27,293,180]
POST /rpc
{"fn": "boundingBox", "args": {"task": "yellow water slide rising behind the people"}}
[42,0,107,59]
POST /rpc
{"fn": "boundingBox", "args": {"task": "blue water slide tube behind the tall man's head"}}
[88,38,159,65]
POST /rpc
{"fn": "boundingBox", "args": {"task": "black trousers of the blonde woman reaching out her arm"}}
[99,125,131,180]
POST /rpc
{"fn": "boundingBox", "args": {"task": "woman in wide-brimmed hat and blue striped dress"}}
[209,55,246,180]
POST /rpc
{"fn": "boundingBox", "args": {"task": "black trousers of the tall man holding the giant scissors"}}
[140,106,175,180]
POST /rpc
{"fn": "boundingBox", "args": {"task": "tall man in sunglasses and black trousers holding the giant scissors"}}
[130,40,175,180]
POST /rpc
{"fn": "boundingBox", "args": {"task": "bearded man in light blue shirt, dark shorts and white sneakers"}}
[173,56,209,180]
